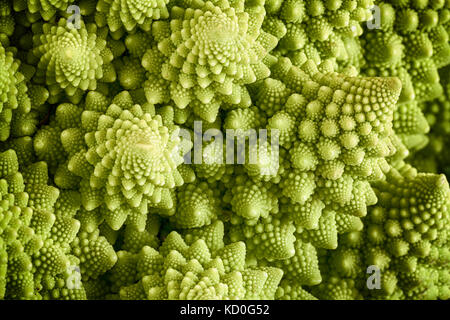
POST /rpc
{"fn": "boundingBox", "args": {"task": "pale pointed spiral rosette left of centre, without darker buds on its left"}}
[61,96,183,230]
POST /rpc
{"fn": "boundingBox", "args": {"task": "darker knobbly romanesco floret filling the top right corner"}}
[362,1,450,101]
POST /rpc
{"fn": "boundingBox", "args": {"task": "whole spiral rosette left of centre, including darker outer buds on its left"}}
[34,91,183,230]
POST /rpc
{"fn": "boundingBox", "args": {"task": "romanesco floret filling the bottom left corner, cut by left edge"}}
[0,150,86,299]
